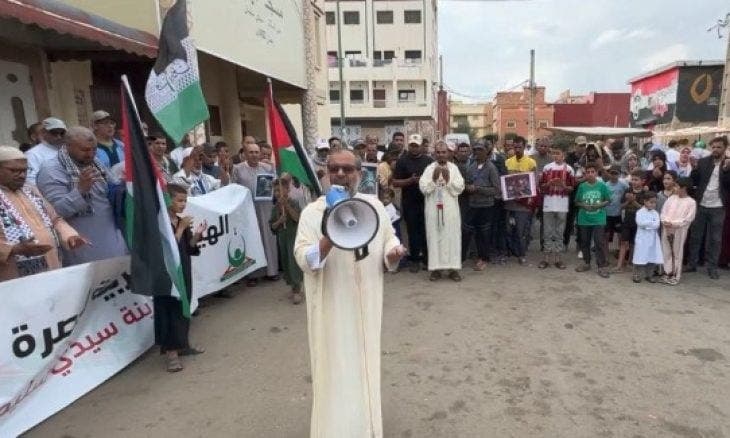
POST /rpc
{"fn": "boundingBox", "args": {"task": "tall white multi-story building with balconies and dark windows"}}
[325,0,438,143]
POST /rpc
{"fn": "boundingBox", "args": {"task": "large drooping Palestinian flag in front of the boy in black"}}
[122,76,190,318]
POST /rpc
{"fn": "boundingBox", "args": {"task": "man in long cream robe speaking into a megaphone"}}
[294,151,405,438]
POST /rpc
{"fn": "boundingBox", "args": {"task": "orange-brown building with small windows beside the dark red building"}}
[492,87,554,142]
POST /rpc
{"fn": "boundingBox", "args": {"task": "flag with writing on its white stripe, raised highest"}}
[145,0,209,143]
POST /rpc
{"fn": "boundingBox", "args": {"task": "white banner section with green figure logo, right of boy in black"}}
[185,184,266,302]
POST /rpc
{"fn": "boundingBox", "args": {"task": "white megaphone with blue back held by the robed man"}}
[322,185,380,262]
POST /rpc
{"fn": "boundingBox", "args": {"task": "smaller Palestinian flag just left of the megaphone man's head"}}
[264,81,322,197]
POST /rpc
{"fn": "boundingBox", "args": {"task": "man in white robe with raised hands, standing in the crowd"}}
[419,142,464,281]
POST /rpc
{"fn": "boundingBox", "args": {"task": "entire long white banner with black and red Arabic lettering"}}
[0,184,266,437]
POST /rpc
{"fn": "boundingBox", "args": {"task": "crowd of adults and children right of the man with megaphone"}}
[314,133,730,285]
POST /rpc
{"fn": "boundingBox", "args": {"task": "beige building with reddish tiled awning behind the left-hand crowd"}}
[0,0,330,149]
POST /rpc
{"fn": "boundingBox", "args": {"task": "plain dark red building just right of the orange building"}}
[553,90,631,127]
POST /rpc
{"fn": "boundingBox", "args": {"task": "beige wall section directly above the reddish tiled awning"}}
[59,0,159,35]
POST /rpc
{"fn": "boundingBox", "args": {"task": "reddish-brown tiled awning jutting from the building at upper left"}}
[0,0,158,58]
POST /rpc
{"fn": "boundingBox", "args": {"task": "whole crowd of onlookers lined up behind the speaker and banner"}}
[0,110,730,370]
